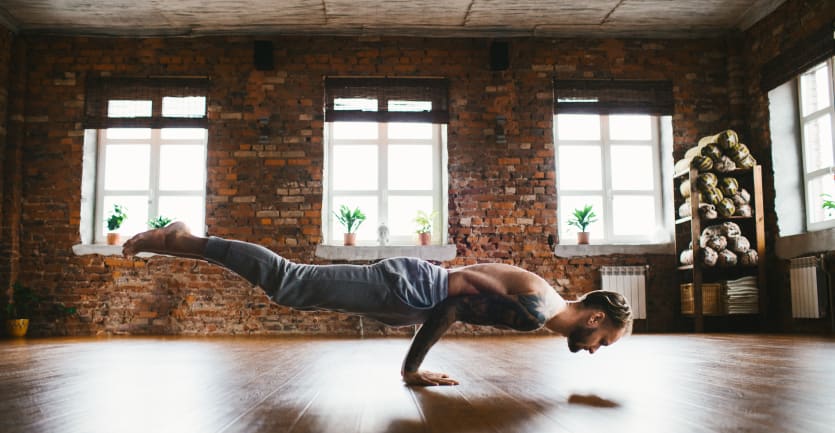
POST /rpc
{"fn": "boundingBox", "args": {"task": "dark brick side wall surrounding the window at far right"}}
[744,0,835,331]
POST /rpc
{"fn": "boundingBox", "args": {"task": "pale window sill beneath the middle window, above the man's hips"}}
[316,245,458,262]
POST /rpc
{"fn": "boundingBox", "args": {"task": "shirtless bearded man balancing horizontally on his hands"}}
[123,222,632,386]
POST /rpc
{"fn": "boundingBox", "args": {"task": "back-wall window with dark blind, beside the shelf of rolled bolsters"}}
[554,80,673,244]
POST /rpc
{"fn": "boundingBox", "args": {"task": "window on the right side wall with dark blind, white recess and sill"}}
[760,23,835,255]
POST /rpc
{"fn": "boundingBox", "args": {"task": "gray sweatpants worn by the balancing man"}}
[203,237,448,326]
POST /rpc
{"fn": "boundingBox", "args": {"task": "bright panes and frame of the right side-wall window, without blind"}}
[797,58,835,230]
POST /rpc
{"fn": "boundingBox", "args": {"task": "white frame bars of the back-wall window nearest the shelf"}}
[553,114,669,245]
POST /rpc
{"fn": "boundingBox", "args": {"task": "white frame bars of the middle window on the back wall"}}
[322,122,447,245]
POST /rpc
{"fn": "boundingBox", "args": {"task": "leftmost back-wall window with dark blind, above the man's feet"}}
[81,78,208,243]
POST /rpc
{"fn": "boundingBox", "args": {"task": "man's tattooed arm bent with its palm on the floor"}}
[401,294,547,386]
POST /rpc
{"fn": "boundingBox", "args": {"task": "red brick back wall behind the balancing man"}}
[3,27,749,335]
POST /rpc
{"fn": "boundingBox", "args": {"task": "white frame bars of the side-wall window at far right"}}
[797,57,835,231]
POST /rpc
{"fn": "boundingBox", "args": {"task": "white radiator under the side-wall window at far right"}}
[789,257,826,319]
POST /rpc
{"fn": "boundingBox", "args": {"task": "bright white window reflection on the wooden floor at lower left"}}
[6,341,235,433]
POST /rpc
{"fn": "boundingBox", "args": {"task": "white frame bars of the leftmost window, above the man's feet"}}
[93,128,208,243]
